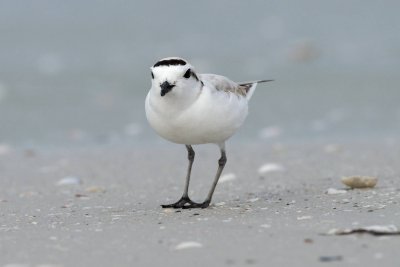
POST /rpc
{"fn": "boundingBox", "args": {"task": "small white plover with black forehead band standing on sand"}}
[145,57,271,208]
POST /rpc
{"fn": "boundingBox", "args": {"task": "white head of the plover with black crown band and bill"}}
[150,57,201,97]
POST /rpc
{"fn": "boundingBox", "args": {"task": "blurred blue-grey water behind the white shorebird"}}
[0,0,400,146]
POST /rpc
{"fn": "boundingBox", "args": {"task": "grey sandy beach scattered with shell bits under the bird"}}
[0,140,400,266]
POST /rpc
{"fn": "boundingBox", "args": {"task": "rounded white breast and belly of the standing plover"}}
[146,89,248,145]
